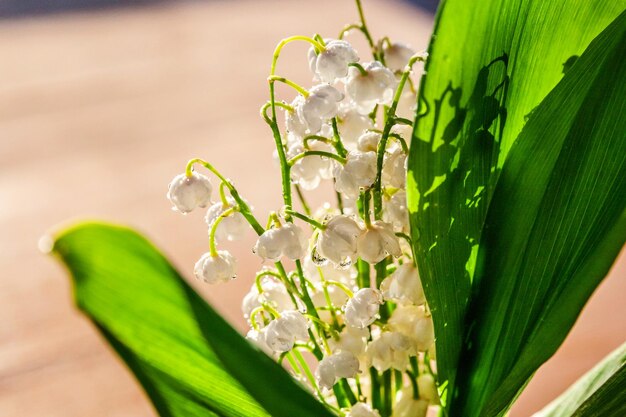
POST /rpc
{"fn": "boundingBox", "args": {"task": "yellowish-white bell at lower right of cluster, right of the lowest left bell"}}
[366,332,412,372]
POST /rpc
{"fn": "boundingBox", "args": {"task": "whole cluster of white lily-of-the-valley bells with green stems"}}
[168,4,439,417]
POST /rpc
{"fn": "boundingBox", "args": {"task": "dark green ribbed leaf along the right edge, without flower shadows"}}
[452,12,626,416]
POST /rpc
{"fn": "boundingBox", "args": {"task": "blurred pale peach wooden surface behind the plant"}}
[0,0,626,417]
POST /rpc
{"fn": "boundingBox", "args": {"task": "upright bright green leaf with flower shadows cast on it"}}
[407,0,626,402]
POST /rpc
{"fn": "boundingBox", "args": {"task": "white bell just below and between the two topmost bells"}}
[346,61,397,114]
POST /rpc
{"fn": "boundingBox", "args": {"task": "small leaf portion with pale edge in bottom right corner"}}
[533,343,626,417]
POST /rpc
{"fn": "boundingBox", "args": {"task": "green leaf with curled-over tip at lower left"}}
[53,223,332,417]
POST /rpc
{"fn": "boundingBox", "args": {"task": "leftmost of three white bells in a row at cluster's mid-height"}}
[253,223,309,262]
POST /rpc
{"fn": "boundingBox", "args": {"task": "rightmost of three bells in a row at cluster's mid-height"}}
[357,220,402,264]
